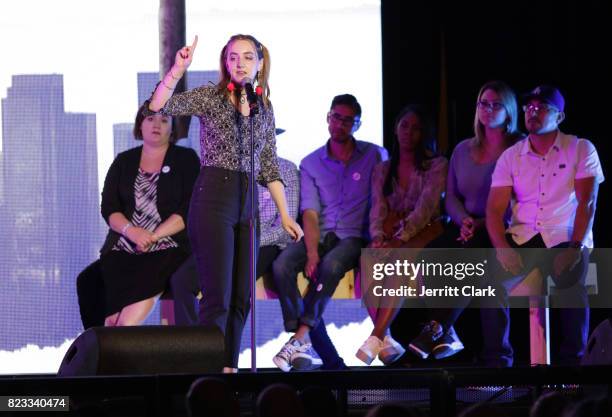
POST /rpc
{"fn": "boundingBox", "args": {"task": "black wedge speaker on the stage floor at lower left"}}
[57,326,224,376]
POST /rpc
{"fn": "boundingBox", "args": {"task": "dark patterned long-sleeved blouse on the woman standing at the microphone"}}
[161,86,282,185]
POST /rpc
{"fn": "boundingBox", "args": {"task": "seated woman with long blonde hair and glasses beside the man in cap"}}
[408,81,522,359]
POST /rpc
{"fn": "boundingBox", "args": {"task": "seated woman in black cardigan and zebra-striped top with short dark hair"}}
[100,102,200,326]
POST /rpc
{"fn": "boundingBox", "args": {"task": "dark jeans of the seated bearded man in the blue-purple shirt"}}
[272,235,364,369]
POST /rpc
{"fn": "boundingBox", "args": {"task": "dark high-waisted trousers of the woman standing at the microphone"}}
[188,167,257,368]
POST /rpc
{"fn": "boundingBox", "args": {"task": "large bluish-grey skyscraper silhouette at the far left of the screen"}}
[0,75,104,349]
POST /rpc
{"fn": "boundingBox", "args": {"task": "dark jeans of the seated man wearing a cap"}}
[481,234,589,366]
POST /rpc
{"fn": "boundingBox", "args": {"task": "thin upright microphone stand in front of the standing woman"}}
[249,95,259,372]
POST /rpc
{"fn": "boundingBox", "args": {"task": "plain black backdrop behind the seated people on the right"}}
[381,0,612,364]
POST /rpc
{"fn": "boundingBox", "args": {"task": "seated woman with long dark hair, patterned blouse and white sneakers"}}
[356,105,448,365]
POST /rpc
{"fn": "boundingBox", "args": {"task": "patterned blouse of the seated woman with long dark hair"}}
[370,156,448,242]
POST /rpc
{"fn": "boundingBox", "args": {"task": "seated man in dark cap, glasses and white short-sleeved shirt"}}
[483,85,604,366]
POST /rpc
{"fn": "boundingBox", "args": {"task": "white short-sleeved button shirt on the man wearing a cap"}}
[491,131,604,248]
